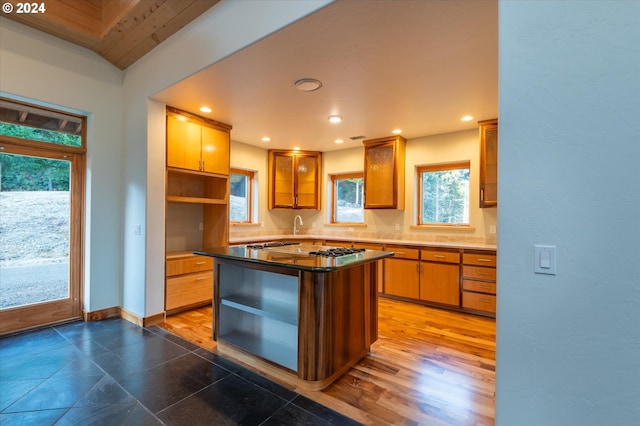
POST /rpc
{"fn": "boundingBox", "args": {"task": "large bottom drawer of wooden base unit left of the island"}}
[165,271,213,311]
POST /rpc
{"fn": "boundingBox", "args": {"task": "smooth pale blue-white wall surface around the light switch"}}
[496,1,640,426]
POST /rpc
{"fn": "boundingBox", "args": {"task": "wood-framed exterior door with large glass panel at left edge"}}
[0,99,84,334]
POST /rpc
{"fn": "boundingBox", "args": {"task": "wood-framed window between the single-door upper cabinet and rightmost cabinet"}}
[417,161,469,225]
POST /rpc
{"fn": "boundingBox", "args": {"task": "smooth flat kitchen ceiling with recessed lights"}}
[155,0,498,151]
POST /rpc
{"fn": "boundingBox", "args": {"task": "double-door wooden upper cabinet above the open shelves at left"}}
[167,107,231,175]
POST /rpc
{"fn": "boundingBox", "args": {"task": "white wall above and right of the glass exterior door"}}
[0,17,122,311]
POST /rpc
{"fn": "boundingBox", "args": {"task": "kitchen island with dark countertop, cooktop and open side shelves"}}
[194,244,393,390]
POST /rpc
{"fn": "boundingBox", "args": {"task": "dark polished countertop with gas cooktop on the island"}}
[193,245,393,272]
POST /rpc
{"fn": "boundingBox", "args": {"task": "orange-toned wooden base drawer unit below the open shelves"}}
[165,252,213,313]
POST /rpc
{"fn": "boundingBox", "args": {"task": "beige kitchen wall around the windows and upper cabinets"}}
[230,129,497,243]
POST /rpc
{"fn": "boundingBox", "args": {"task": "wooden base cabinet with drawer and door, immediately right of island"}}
[384,245,420,299]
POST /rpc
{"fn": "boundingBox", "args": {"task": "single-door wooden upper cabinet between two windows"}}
[364,136,406,209]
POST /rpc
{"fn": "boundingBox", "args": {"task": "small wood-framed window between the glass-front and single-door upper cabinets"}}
[331,172,364,223]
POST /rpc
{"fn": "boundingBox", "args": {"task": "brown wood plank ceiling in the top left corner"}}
[4,0,220,70]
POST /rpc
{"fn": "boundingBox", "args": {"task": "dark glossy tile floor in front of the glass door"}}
[0,319,358,426]
